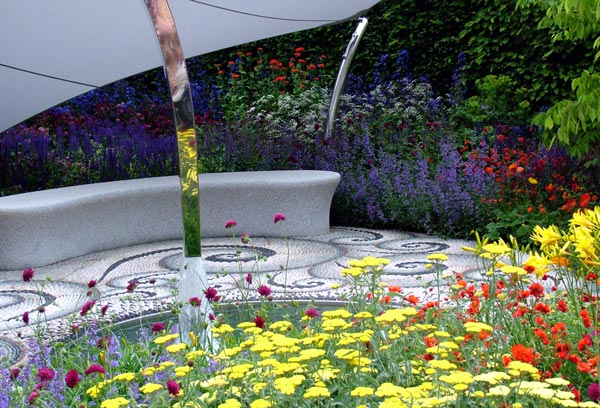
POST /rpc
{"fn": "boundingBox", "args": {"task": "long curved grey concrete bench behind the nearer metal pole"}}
[0,170,340,270]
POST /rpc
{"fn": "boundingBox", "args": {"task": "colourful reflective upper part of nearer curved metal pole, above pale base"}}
[145,0,200,257]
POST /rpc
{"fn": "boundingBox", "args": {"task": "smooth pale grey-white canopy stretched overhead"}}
[0,0,379,131]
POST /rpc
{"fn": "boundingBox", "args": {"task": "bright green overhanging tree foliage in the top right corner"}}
[517,0,600,165]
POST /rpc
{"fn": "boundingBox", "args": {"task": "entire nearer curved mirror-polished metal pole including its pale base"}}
[144,0,217,350]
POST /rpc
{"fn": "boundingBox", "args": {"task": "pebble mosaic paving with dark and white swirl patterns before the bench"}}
[0,227,478,363]
